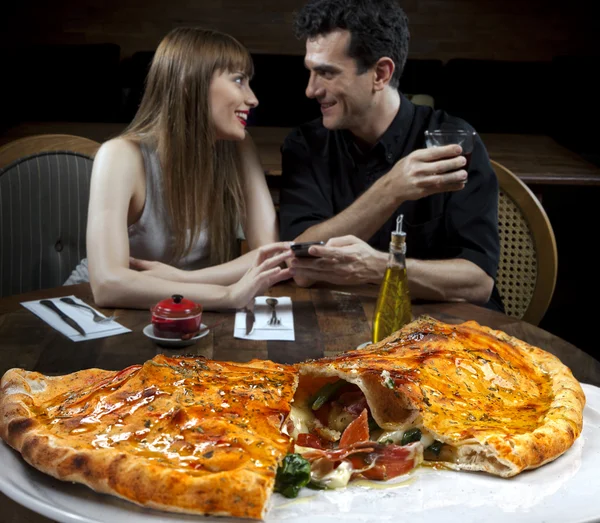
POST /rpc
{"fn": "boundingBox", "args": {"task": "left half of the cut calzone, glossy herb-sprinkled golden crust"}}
[0,355,297,519]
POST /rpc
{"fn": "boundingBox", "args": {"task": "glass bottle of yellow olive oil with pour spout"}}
[373,215,412,343]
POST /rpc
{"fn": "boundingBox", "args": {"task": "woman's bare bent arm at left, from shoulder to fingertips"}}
[87,139,291,309]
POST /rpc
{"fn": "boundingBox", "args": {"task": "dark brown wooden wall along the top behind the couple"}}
[0,0,600,60]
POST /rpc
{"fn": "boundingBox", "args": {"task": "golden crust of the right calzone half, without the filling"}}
[295,317,585,477]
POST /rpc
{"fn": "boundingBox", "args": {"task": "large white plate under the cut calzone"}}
[0,385,600,523]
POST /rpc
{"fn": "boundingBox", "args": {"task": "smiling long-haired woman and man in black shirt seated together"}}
[70,0,502,316]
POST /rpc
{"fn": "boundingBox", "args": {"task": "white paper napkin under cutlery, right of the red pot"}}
[233,296,296,341]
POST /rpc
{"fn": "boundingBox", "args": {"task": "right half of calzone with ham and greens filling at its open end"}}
[286,317,585,494]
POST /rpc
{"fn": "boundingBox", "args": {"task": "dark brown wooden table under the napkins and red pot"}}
[0,283,600,523]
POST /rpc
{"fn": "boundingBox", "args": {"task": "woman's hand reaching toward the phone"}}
[229,242,294,309]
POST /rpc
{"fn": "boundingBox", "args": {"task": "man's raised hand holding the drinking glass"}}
[383,145,467,202]
